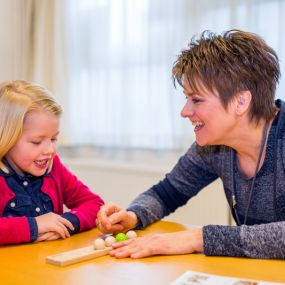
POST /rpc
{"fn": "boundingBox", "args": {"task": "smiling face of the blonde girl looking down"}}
[6,111,60,176]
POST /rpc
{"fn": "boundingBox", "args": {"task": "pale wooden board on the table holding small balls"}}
[46,243,111,266]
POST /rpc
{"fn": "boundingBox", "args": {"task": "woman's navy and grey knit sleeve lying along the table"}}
[203,222,285,259]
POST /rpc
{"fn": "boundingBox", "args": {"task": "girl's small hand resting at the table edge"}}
[35,213,74,239]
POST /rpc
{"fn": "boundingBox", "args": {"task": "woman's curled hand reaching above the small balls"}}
[96,203,138,233]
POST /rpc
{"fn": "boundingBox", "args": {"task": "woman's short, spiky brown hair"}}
[172,30,280,122]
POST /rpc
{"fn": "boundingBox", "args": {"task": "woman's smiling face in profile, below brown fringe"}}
[181,80,237,146]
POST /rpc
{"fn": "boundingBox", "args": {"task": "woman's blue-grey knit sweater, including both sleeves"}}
[128,100,285,259]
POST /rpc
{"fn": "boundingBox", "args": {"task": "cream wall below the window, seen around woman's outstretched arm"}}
[62,154,229,225]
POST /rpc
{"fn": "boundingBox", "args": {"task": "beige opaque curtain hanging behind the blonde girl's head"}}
[0,0,69,143]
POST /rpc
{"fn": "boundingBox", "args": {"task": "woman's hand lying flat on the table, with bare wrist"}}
[109,228,204,258]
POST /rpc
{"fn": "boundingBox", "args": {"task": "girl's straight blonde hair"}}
[0,80,62,173]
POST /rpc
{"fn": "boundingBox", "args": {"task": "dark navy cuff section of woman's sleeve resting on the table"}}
[203,225,245,257]
